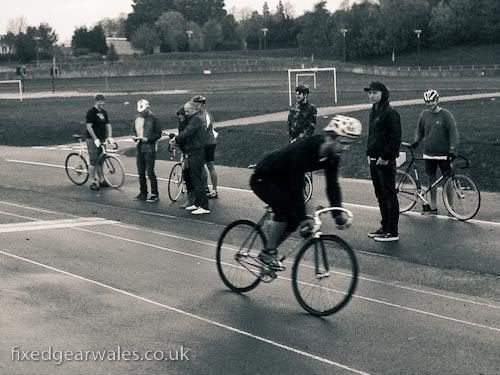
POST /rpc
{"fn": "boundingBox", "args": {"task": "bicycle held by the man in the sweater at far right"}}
[396,142,481,221]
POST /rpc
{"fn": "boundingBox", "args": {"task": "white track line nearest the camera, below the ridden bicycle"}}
[0,250,370,375]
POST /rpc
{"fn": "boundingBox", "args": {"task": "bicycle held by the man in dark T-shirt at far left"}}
[64,135,125,189]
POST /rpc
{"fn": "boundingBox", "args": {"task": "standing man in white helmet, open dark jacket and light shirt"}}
[132,99,161,203]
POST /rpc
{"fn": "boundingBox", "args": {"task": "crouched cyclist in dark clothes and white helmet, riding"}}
[250,116,362,270]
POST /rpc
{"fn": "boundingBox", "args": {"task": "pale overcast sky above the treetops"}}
[0,0,340,44]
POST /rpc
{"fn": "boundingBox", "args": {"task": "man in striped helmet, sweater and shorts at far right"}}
[412,89,458,215]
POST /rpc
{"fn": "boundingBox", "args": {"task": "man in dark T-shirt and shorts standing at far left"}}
[85,94,114,190]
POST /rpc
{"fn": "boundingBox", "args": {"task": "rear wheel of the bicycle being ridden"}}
[216,220,266,293]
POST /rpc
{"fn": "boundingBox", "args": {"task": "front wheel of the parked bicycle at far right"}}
[443,173,481,220]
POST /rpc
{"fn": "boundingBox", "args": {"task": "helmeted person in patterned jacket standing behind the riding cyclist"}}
[287,85,318,142]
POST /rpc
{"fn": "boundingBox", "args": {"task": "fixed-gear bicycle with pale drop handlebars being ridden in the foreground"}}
[216,207,358,316]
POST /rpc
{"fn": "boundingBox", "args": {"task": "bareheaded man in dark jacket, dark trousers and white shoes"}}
[175,102,210,215]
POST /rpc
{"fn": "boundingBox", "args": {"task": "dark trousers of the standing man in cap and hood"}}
[370,160,399,234]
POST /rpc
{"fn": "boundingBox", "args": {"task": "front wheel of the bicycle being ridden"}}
[292,235,358,316]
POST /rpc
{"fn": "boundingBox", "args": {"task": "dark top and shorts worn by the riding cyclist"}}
[252,135,342,221]
